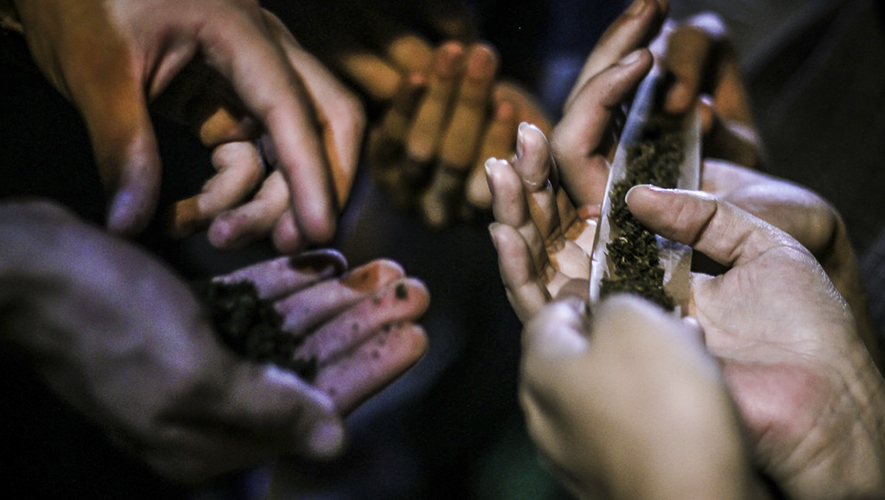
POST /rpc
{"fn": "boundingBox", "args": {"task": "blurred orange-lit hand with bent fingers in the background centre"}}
[369,42,546,227]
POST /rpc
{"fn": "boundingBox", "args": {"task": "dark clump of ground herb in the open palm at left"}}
[194,281,317,382]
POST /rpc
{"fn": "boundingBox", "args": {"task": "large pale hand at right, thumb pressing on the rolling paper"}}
[627,187,885,499]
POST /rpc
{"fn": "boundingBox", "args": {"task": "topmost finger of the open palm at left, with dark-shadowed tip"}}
[213,250,347,301]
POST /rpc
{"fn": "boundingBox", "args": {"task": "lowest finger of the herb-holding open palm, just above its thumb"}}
[314,322,427,415]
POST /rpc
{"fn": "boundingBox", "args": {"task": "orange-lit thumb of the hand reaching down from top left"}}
[74,77,160,234]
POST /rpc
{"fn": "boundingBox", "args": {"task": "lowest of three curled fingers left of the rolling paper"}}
[489,223,550,322]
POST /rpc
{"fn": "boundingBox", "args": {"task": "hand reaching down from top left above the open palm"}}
[8,0,363,249]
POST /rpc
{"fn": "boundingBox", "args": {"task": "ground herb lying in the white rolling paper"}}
[599,114,684,311]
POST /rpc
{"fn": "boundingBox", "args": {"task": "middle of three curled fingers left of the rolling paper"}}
[486,158,550,279]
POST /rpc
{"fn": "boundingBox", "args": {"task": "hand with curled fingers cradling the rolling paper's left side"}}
[486,47,652,321]
